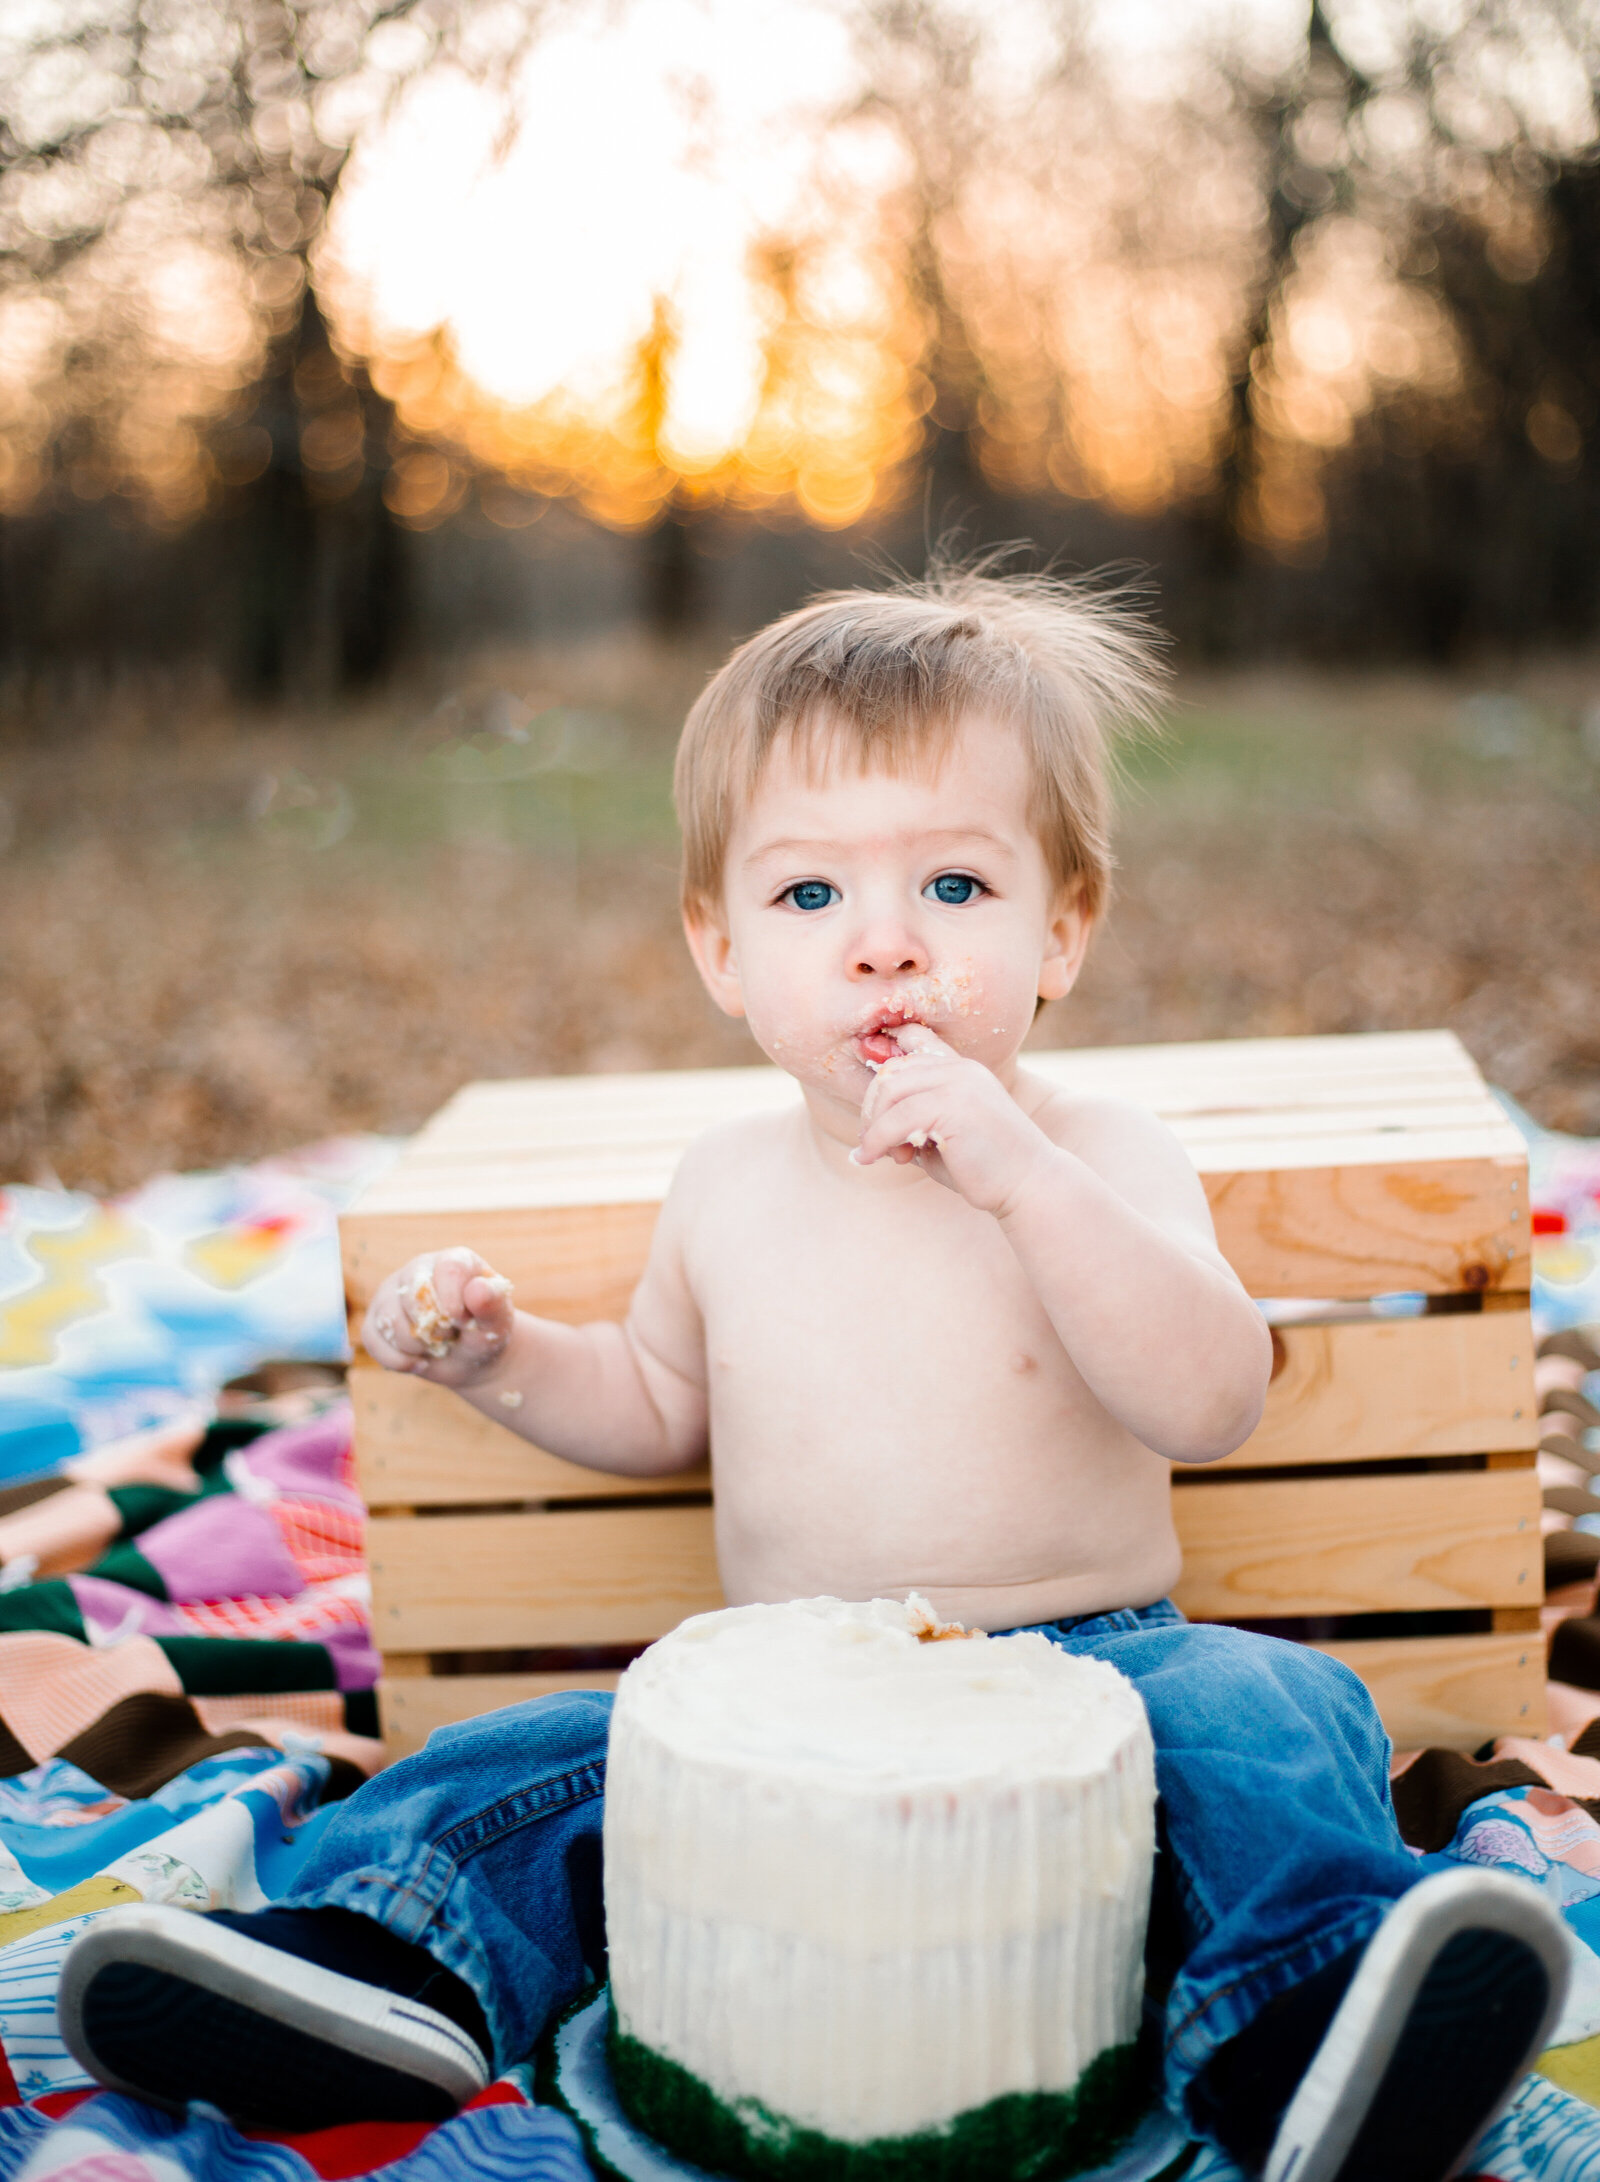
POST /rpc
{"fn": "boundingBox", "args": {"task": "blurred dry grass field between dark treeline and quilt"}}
[0,644,1600,1189]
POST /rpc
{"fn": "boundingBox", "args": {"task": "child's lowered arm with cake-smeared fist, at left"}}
[362,1200,707,1475]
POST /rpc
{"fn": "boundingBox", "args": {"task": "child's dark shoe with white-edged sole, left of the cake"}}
[57,1903,489,2127]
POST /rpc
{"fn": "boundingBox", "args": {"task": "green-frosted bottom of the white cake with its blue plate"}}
[541,1988,1192,2182]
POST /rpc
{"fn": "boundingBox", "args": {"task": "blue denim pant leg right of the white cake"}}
[1021,1602,1423,2112]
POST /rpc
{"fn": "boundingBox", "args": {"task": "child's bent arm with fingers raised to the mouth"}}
[856,1023,1273,1462]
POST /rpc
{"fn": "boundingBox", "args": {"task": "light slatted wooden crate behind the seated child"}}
[343,1032,1543,1750]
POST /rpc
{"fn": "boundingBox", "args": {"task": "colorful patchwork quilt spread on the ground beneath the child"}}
[0,1128,1600,2182]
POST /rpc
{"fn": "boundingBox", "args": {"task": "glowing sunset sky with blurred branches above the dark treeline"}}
[0,0,1593,554]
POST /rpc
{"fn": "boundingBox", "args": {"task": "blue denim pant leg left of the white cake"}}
[282,1689,611,2069]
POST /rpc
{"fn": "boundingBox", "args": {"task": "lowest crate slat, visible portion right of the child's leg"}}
[1316,1634,1545,1750]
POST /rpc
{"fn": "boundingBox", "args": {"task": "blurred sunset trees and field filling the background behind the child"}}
[0,0,1600,1189]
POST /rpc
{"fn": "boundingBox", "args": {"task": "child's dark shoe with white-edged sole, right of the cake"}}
[1264,1870,1569,2182]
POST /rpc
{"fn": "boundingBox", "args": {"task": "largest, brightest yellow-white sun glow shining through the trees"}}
[317,0,917,524]
